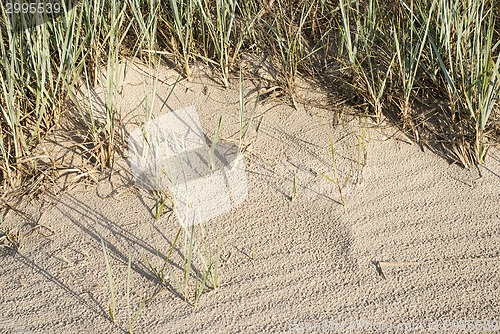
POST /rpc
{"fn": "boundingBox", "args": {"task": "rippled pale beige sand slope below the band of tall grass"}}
[0,62,500,333]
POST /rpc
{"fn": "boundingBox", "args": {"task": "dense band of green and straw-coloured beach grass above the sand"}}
[0,0,500,189]
